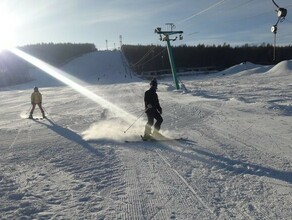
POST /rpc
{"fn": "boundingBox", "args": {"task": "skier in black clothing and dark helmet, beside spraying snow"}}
[144,78,163,139]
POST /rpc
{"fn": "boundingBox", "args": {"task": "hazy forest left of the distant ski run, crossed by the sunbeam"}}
[0,43,97,87]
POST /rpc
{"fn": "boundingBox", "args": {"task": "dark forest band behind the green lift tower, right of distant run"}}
[122,43,292,73]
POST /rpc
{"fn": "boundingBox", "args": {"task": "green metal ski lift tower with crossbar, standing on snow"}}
[154,23,183,89]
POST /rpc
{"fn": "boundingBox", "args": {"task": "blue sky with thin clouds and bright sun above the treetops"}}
[0,0,292,50]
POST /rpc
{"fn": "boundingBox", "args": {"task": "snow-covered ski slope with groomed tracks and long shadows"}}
[0,51,292,219]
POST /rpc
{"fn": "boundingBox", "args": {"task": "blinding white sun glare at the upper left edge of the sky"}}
[0,9,16,52]
